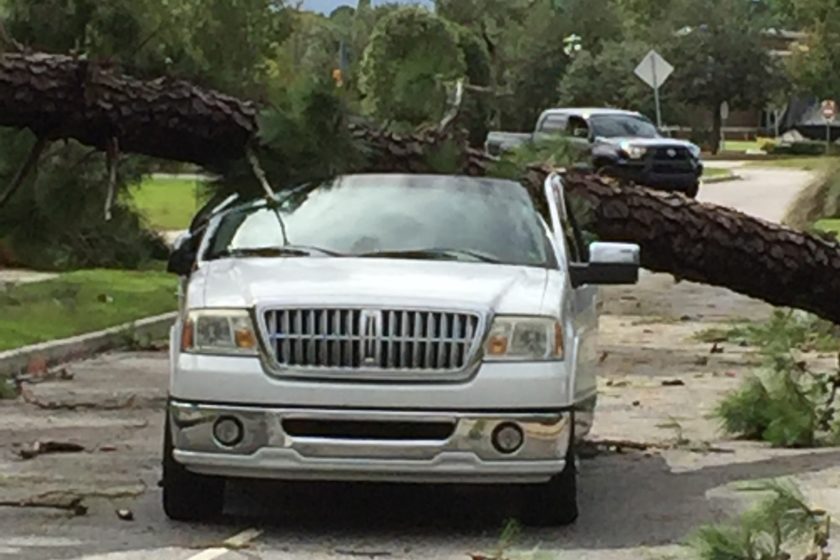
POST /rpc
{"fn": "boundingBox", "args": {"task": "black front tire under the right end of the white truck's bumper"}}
[523,446,578,527]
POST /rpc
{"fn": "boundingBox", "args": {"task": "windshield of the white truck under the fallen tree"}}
[206,175,554,267]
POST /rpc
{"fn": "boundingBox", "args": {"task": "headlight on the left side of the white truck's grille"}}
[181,309,257,354]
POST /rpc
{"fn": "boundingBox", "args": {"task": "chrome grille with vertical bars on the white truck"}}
[264,309,480,372]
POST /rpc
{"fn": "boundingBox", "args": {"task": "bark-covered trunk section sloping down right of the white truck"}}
[529,166,840,324]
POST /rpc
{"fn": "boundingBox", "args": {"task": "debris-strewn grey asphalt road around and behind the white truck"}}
[0,168,828,560]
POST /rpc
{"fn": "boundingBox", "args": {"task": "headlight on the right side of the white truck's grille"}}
[484,316,563,360]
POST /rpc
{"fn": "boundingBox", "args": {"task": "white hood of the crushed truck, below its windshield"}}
[187,257,562,314]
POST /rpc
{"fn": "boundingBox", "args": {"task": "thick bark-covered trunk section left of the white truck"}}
[0,53,257,165]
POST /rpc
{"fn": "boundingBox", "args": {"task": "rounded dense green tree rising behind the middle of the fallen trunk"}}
[360,7,467,126]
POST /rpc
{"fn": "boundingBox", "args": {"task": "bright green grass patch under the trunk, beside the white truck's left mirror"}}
[129,177,204,230]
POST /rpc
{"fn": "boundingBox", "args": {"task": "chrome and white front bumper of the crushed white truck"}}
[169,401,573,483]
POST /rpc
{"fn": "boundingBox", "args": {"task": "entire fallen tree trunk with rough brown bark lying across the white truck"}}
[0,53,840,323]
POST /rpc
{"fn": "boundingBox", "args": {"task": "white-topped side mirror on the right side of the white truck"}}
[569,241,641,288]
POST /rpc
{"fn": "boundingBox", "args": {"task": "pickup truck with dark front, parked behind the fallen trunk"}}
[486,109,703,198]
